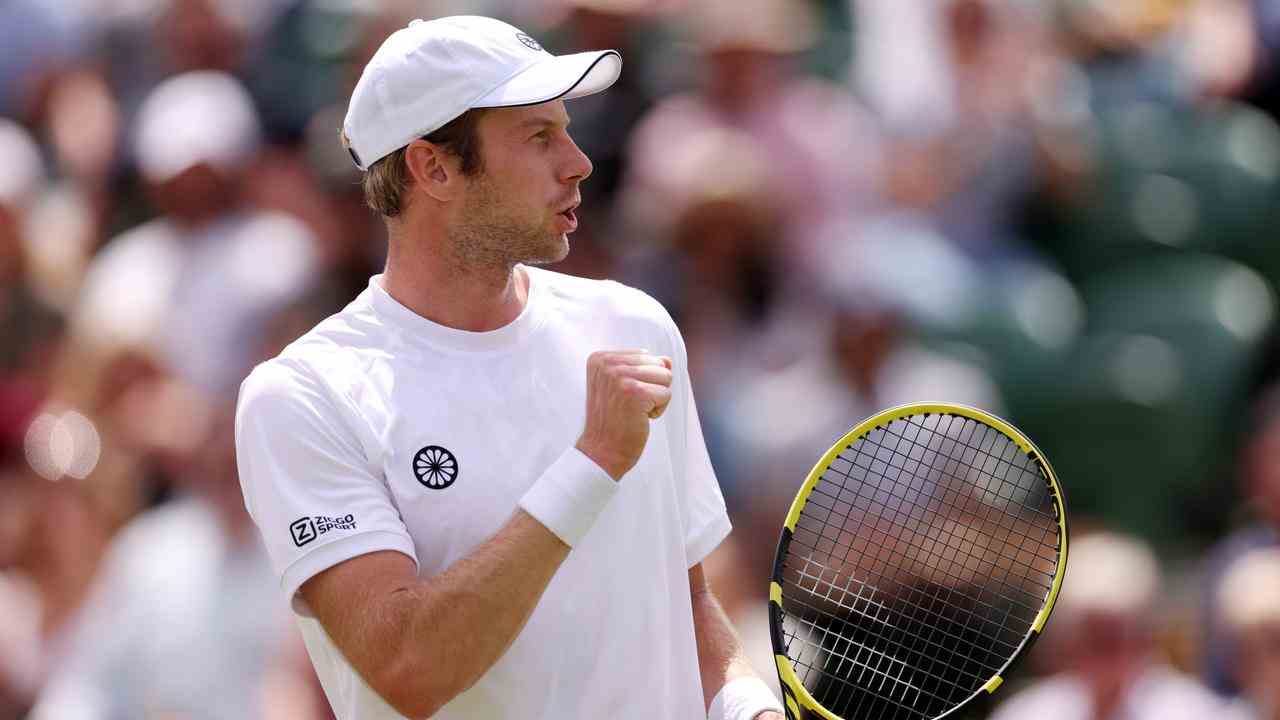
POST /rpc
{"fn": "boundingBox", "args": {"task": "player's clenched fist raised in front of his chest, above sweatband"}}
[576,350,671,480]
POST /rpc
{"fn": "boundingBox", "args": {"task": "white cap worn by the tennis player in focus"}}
[342,15,622,170]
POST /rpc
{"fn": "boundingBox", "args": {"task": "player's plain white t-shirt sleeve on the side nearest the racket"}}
[667,311,732,568]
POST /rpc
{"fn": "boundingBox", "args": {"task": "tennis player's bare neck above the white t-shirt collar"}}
[383,221,529,332]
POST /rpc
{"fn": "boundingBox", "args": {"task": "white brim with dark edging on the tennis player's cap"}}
[471,50,622,108]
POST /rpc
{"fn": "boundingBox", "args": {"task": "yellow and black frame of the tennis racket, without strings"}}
[769,402,1068,720]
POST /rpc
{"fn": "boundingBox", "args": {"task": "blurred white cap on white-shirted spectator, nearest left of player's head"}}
[134,70,261,182]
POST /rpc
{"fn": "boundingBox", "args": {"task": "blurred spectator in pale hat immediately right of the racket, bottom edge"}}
[992,532,1222,720]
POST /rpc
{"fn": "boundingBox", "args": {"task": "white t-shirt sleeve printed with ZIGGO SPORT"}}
[236,360,417,615]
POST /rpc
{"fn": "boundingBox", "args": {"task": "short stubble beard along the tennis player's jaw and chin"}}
[447,177,568,273]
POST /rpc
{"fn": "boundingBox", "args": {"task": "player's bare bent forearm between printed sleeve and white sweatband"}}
[360,510,570,716]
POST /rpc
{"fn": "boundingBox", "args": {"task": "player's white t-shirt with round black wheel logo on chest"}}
[237,268,730,720]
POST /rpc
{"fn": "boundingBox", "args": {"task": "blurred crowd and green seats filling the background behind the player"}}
[0,0,1280,720]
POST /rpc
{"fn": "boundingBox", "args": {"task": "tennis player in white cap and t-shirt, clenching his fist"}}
[237,17,781,720]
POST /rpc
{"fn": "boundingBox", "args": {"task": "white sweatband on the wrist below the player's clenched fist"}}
[520,447,618,547]
